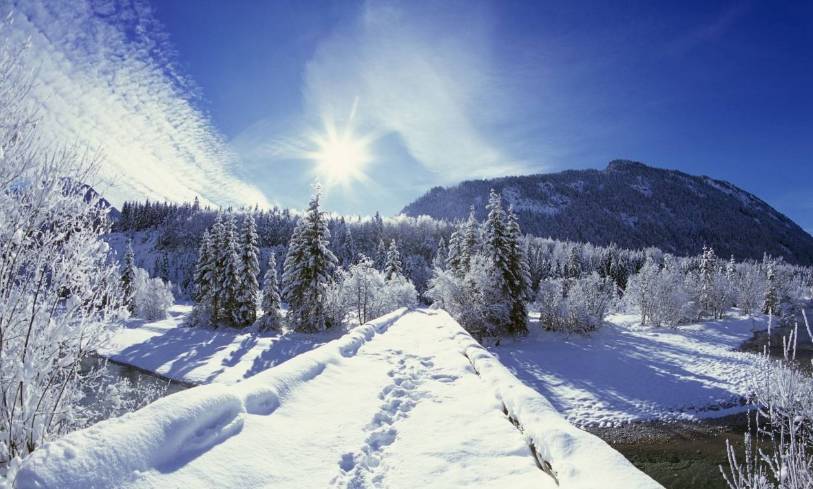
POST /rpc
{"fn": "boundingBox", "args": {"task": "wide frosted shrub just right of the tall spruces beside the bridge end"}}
[536,272,615,333]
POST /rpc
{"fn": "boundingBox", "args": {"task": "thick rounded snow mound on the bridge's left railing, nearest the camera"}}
[15,385,245,489]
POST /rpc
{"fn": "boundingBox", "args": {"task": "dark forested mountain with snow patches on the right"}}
[401,160,813,265]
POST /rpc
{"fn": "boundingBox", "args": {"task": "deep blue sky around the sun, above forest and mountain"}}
[11,0,813,230]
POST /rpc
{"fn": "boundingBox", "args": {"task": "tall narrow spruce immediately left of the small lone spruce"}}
[233,213,260,326]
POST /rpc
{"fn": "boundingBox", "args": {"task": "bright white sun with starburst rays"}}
[308,119,372,186]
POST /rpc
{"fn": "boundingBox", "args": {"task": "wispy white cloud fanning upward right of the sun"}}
[305,2,523,181]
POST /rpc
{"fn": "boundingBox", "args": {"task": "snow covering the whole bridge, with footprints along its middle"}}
[16,309,660,489]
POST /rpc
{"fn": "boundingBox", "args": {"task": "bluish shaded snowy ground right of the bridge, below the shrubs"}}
[490,315,767,426]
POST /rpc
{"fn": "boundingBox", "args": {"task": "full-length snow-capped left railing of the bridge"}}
[15,308,406,489]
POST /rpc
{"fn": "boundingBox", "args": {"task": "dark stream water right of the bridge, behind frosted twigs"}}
[589,312,813,489]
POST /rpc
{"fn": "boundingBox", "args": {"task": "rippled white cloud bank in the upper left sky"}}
[8,0,267,205]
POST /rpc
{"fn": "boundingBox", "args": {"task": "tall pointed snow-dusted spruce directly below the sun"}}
[282,188,337,331]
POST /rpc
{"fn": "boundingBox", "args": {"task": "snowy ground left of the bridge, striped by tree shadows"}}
[99,304,344,384]
